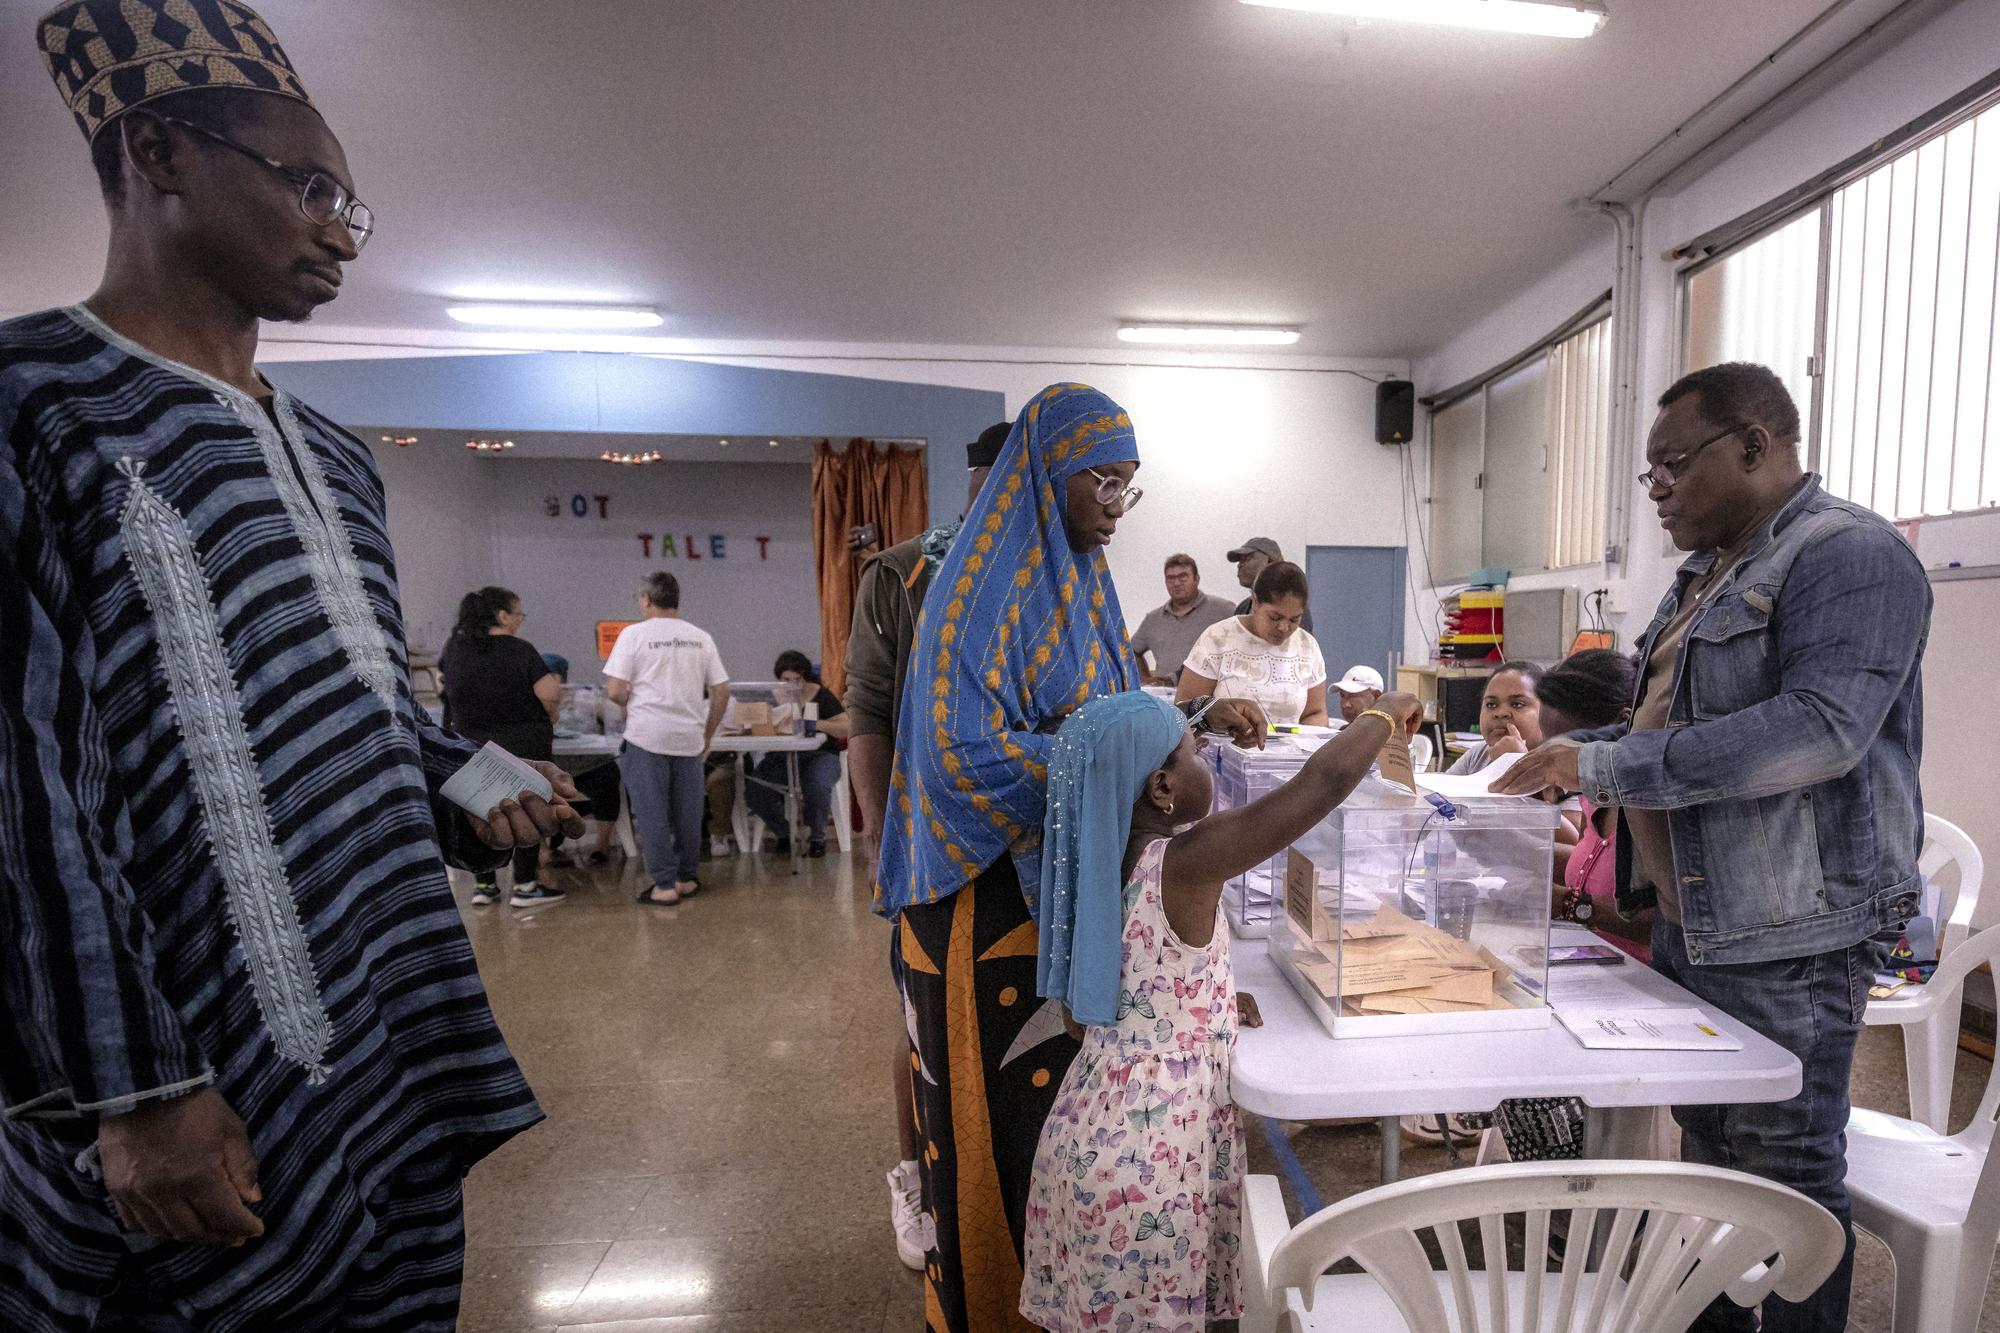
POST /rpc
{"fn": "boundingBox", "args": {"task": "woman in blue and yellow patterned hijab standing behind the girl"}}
[876,384,1262,1333]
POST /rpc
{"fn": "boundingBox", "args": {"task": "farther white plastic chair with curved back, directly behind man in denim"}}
[1864,815,1986,1135]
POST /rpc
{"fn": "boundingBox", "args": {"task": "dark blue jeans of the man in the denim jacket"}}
[1652,917,1884,1333]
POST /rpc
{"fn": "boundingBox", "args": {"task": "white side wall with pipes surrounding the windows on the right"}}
[1412,0,2000,642]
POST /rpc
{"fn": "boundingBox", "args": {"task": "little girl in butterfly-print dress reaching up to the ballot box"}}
[1020,693,1420,1333]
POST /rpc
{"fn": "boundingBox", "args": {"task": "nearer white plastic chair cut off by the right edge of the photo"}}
[1848,904,2000,1333]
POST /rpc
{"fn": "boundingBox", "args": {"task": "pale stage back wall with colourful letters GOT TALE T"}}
[376,454,820,685]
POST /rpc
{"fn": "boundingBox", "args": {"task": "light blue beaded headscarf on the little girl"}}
[1034,691,1188,1023]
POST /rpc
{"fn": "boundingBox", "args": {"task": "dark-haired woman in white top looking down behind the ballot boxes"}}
[1176,560,1326,727]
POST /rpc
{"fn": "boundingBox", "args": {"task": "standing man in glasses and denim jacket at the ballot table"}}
[1498,362,1930,1333]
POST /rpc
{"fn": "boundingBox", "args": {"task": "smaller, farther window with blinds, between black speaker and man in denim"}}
[1430,314,1612,584]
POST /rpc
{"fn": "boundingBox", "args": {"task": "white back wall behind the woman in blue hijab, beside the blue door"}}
[704,352,1420,640]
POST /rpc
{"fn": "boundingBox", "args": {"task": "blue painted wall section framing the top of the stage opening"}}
[264,352,1006,522]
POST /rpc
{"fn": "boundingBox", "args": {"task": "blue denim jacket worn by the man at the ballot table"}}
[1578,476,1930,963]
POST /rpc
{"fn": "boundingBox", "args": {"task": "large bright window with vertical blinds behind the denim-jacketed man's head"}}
[1682,91,2000,520]
